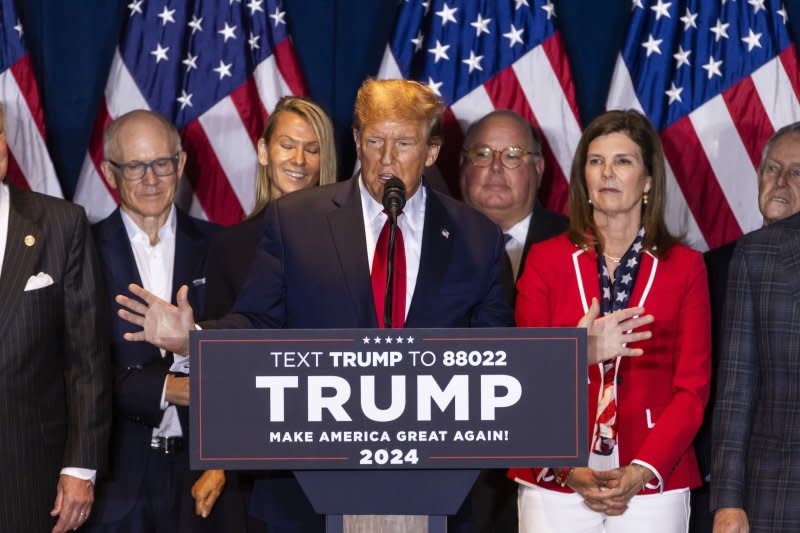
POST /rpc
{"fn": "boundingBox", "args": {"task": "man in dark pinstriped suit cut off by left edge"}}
[0,105,111,533]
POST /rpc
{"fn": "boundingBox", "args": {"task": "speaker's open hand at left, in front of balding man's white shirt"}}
[116,283,195,355]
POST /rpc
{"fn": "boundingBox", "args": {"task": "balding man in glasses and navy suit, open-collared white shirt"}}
[87,110,216,533]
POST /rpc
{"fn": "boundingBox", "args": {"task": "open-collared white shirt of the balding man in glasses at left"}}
[120,206,183,437]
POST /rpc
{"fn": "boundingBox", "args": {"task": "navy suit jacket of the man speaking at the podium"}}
[209,178,514,328]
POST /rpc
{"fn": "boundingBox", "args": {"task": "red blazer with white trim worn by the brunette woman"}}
[509,234,711,492]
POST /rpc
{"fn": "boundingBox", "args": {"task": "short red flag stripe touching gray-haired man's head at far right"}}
[722,76,775,168]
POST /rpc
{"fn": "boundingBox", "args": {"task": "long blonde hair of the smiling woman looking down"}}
[252,96,336,218]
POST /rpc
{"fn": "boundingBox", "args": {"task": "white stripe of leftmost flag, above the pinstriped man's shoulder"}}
[0,69,63,198]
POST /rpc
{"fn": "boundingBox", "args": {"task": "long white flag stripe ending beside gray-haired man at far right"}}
[689,95,762,233]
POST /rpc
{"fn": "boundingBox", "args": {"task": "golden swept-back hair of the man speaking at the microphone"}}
[353,78,444,142]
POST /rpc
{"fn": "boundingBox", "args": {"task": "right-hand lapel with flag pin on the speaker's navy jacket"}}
[406,187,458,327]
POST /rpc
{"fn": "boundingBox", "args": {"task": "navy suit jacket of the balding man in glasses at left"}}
[92,208,217,522]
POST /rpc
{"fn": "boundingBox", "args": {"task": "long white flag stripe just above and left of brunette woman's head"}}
[513,46,581,181]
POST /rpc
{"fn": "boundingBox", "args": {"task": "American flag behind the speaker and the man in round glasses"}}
[378,0,581,212]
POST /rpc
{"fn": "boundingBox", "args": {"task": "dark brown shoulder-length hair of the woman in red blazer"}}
[569,109,679,257]
